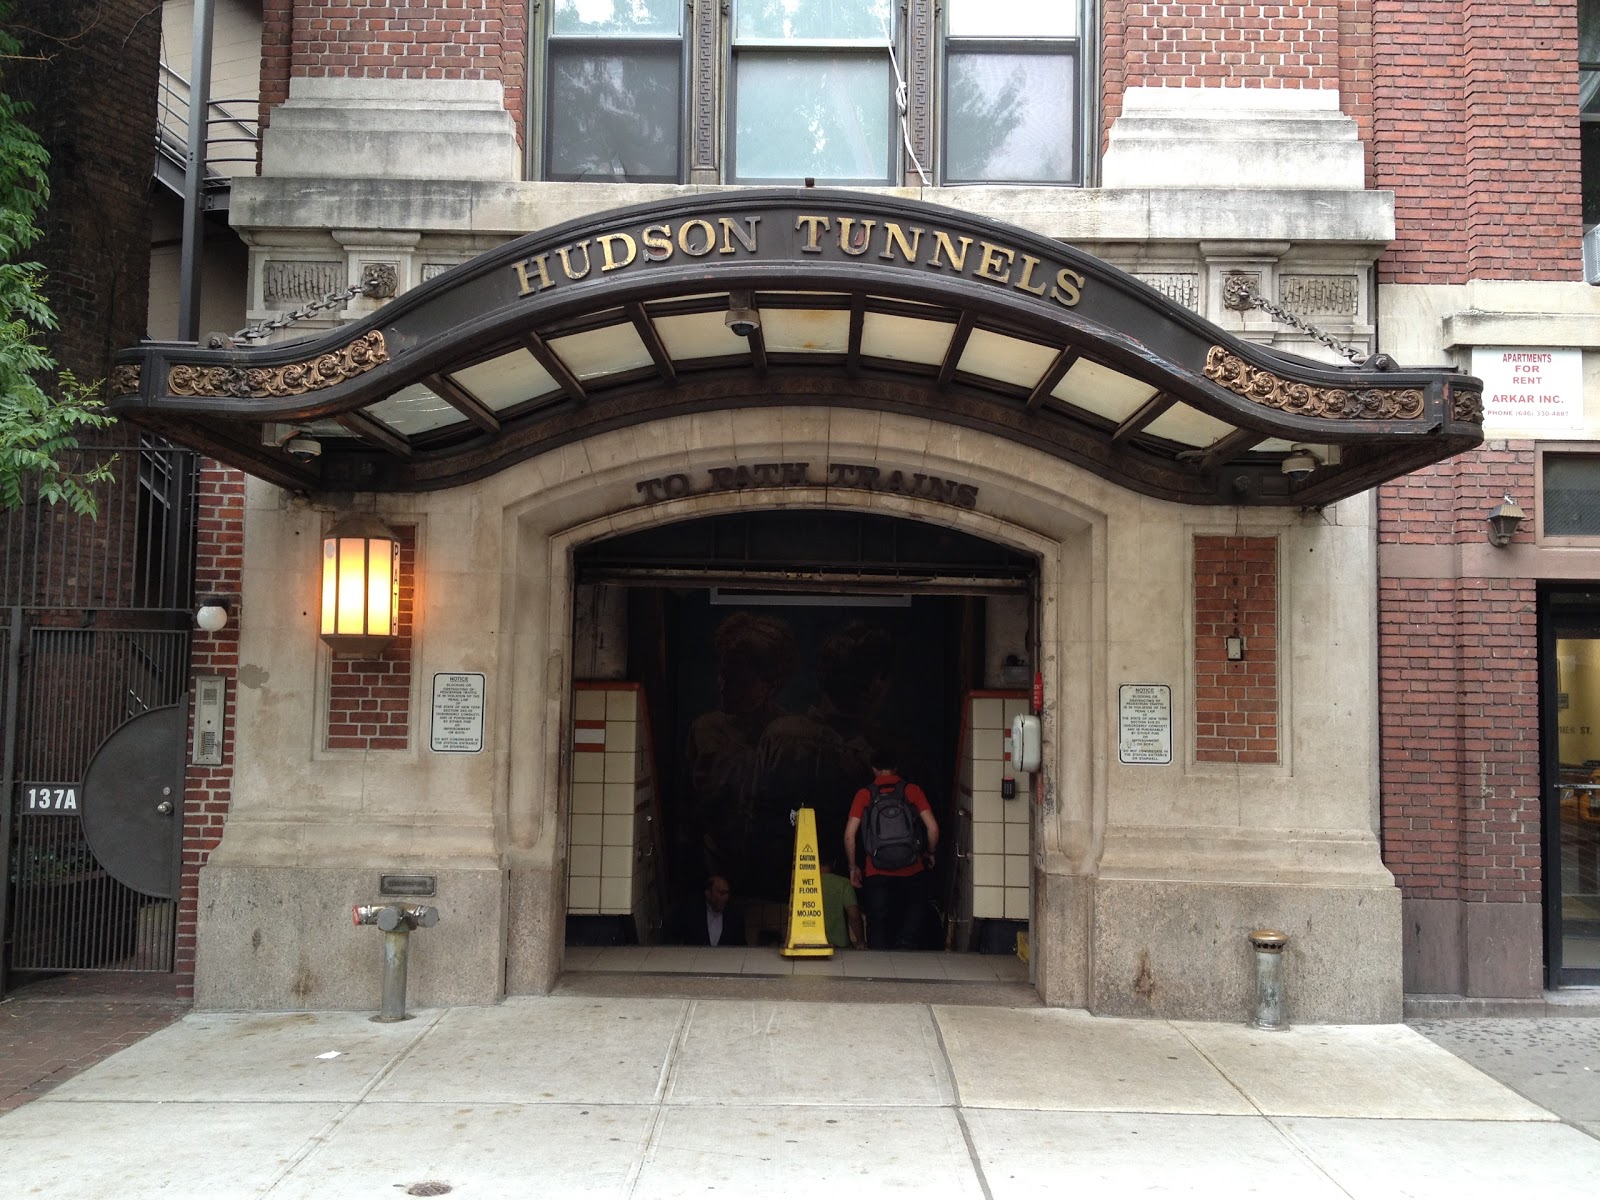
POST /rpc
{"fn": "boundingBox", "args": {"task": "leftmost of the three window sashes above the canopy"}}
[544,0,685,182]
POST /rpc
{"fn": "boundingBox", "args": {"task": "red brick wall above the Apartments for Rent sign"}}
[1373,0,1582,283]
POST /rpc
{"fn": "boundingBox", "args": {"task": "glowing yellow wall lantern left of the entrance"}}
[322,517,400,658]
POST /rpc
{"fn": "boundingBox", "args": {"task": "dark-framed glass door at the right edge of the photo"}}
[1542,592,1600,986]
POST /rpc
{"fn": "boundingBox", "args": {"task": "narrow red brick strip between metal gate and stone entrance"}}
[176,459,245,997]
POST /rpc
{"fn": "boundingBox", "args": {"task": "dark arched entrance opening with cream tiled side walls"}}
[568,510,1037,971]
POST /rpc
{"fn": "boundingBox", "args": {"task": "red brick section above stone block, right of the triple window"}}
[1101,0,1366,140]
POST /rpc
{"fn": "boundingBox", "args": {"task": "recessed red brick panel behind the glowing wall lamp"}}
[326,525,416,750]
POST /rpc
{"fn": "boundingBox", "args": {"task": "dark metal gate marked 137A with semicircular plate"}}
[0,440,195,995]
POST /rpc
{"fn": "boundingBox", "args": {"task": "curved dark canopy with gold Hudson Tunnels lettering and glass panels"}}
[112,189,1482,506]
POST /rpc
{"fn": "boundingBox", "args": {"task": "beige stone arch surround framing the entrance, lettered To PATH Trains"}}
[486,410,1125,1005]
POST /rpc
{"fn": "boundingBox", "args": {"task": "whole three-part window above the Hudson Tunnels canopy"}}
[530,0,1094,186]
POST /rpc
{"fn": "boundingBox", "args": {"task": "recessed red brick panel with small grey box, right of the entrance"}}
[1194,534,1278,763]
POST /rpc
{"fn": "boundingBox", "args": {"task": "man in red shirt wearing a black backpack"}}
[845,766,939,950]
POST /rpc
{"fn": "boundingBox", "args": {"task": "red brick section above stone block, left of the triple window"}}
[261,0,528,139]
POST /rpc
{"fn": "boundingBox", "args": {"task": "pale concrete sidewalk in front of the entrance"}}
[0,995,1600,1200]
